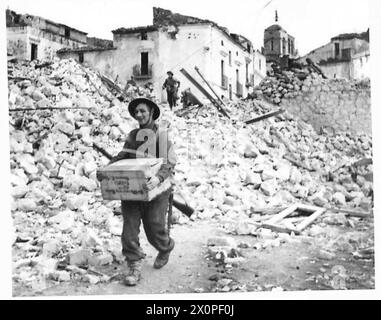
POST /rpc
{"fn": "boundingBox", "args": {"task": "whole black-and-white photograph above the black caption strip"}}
[2,0,377,299]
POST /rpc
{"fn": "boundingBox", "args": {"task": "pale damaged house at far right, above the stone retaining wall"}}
[300,29,370,79]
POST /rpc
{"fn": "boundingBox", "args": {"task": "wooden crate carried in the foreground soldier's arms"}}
[97,158,171,201]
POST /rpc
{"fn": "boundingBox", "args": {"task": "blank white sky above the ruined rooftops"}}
[2,0,373,55]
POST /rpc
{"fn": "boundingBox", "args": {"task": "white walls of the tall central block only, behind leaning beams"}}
[155,24,254,101]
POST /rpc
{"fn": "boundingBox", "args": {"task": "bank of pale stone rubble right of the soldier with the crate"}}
[167,101,372,218]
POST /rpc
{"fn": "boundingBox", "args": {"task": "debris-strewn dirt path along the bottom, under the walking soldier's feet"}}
[14,220,374,296]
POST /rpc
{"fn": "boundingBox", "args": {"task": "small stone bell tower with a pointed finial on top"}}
[264,15,297,62]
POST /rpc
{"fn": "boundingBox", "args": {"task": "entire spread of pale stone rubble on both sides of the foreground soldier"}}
[9,60,372,290]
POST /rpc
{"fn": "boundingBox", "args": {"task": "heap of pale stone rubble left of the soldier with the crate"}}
[8,60,150,289]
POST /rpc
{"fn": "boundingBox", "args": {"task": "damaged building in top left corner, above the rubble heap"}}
[6,10,87,60]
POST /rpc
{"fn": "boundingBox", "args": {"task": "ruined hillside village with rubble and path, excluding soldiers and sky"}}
[6,8,374,296]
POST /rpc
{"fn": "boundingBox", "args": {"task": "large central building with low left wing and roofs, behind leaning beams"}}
[58,8,266,101]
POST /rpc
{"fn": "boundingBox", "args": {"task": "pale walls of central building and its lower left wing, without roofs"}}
[107,23,254,102]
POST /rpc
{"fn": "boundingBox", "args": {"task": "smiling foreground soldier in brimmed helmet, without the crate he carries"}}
[104,98,176,286]
